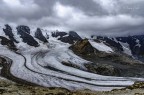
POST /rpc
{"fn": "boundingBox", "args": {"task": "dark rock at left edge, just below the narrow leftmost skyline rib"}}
[0,36,17,51]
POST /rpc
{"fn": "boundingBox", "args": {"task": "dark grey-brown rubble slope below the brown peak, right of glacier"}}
[81,54,144,77]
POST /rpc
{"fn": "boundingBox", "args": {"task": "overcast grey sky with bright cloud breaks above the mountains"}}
[0,0,144,35]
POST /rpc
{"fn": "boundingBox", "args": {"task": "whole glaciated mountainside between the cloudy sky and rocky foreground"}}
[0,25,144,91]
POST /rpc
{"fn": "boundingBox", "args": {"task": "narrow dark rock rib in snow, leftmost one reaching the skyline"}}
[3,24,18,43]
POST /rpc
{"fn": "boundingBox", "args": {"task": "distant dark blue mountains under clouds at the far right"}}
[93,35,144,56]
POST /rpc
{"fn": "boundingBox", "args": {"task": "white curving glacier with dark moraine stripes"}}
[0,35,144,91]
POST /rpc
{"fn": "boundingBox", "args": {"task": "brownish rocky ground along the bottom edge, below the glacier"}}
[0,79,144,95]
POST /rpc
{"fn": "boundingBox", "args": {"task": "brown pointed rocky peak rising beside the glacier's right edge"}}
[70,39,94,54]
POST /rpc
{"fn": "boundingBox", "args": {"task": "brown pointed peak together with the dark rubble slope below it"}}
[70,39,144,77]
